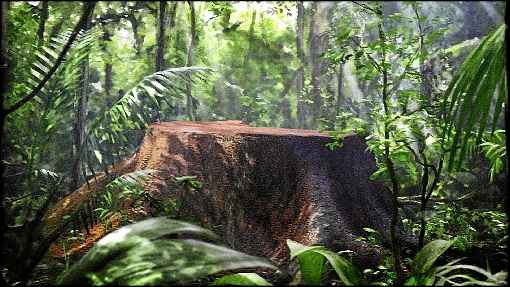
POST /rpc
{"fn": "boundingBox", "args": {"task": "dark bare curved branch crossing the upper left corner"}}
[3,2,96,117]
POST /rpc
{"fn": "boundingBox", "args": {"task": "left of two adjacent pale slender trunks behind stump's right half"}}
[296,1,306,128]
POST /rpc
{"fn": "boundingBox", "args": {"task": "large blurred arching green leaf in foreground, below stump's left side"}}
[58,217,275,285]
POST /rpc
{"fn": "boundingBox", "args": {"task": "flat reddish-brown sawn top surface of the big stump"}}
[152,120,329,138]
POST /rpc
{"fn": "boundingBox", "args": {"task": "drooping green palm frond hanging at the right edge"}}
[444,24,507,171]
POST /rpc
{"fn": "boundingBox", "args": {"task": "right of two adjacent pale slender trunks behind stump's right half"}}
[308,2,322,124]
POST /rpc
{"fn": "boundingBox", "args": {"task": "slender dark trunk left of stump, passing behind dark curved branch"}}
[71,6,93,190]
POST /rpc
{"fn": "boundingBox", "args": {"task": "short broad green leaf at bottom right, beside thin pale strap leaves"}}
[411,240,452,275]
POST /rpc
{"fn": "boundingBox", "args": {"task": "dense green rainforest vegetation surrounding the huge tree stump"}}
[0,1,508,286]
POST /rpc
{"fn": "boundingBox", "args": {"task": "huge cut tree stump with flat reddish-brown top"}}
[44,121,402,265]
